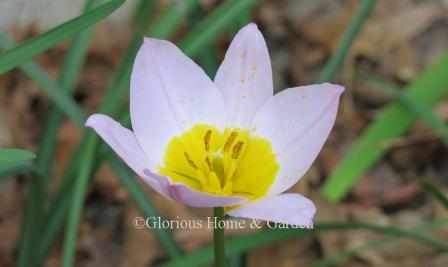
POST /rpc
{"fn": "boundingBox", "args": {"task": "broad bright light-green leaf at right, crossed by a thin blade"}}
[322,53,448,201]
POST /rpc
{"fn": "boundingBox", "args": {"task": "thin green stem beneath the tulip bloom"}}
[213,207,227,267]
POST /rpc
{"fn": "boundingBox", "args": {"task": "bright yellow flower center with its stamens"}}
[159,124,279,200]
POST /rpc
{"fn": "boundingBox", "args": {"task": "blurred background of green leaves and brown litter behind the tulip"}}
[0,0,448,267]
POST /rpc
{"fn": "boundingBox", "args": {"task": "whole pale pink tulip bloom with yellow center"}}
[86,23,344,227]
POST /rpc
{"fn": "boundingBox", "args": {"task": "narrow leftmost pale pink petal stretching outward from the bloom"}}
[85,114,164,198]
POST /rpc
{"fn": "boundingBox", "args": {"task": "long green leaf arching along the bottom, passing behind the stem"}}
[160,222,448,267]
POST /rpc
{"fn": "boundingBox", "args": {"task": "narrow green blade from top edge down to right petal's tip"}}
[317,0,375,83]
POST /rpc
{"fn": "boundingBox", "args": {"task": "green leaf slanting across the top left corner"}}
[0,0,125,74]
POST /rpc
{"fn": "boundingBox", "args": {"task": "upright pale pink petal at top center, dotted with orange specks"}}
[214,23,273,128]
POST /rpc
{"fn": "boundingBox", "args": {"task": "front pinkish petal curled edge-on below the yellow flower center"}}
[146,171,247,208]
